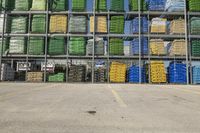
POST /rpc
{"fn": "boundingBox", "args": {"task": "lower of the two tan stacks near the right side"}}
[169,39,186,56]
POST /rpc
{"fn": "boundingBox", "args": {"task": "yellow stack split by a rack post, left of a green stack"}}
[90,16,108,33]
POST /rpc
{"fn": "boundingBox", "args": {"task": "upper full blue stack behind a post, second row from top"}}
[133,17,148,34]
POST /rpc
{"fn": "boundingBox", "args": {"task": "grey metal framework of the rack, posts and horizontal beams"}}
[0,0,200,84]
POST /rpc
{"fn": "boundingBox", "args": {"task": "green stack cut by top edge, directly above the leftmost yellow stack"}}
[51,0,68,11]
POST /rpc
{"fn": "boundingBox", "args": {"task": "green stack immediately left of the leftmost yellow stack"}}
[31,15,46,33]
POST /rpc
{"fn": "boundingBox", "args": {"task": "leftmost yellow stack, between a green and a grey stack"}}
[49,15,67,33]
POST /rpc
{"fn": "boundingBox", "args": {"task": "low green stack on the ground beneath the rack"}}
[48,73,65,82]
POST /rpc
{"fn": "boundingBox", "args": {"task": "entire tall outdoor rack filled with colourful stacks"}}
[0,0,200,84]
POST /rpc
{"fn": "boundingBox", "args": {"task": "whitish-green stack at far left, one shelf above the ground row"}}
[9,37,27,54]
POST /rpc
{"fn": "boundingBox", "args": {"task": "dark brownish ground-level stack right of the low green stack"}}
[68,65,86,82]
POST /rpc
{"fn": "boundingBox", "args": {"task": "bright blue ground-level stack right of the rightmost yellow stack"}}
[168,62,187,84]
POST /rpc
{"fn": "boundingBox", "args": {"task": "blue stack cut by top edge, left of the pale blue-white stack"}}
[148,0,166,11]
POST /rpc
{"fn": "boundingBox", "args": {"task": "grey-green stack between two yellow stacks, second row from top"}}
[69,16,87,33]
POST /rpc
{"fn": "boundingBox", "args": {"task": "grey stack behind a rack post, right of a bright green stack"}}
[87,38,105,55]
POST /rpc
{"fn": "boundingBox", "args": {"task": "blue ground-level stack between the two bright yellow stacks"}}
[128,66,146,83]
